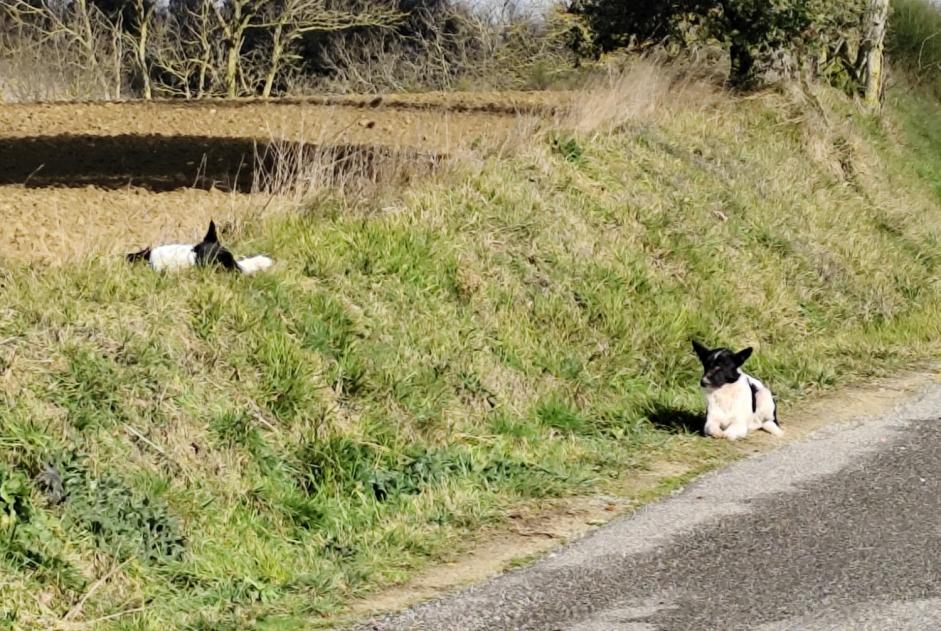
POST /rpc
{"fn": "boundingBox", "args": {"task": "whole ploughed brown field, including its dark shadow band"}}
[0,93,569,264]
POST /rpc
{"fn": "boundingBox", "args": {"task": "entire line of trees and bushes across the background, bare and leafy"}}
[0,0,941,103]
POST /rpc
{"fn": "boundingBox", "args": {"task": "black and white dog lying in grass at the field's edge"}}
[126,221,274,274]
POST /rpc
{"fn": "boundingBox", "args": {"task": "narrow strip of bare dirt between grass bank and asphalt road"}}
[345,371,941,622]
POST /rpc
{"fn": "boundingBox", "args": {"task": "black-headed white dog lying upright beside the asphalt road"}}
[693,340,784,440]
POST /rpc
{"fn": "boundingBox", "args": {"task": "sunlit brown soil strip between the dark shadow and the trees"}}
[0,99,544,152]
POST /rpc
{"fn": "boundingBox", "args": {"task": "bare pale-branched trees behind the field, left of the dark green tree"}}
[0,0,575,98]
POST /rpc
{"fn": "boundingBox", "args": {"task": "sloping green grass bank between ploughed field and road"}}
[0,79,941,629]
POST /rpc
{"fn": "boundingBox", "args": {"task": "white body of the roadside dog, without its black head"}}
[703,372,784,440]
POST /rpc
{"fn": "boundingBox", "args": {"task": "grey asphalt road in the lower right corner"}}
[358,386,941,631]
